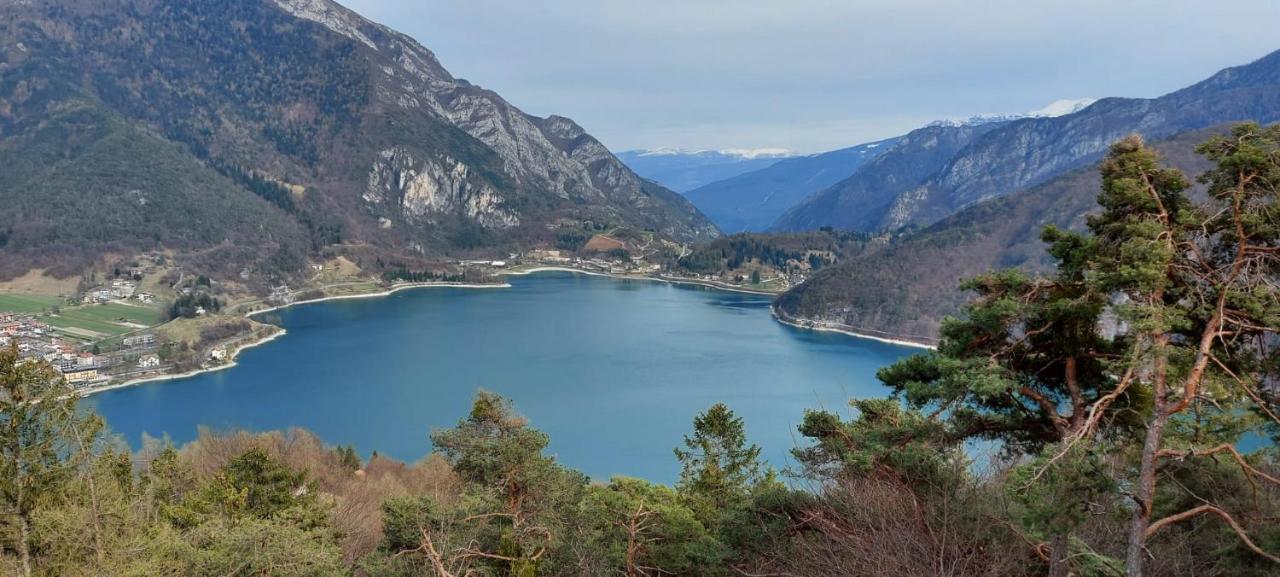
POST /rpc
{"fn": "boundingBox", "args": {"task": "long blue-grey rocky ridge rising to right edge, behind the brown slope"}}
[777,51,1280,232]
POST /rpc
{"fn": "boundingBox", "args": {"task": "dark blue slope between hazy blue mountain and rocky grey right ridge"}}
[773,120,1009,232]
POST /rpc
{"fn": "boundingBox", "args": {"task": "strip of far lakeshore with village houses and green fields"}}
[0,235,829,393]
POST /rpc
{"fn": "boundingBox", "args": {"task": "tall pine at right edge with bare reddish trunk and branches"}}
[1089,124,1280,577]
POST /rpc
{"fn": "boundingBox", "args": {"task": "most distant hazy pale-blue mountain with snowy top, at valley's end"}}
[618,148,792,193]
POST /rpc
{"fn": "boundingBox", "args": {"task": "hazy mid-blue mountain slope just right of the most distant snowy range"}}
[685,138,897,233]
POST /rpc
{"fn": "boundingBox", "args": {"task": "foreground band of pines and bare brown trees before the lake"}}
[0,124,1280,577]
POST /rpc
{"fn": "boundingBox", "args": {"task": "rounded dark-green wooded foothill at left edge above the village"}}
[0,102,308,278]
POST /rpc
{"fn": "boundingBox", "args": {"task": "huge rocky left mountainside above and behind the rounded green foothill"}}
[0,0,718,281]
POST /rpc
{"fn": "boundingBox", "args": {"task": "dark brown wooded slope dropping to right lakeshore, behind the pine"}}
[776,128,1225,342]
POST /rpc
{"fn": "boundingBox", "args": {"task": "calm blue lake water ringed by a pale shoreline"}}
[90,273,918,482]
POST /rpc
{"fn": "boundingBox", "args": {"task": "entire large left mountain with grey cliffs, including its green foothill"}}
[0,0,718,282]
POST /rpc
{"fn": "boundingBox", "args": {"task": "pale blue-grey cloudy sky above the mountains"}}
[339,0,1280,154]
